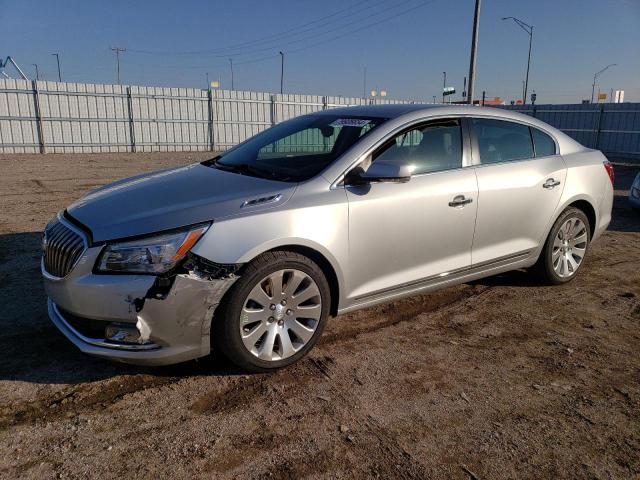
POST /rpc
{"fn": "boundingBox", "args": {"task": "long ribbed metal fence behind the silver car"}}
[7,79,640,156]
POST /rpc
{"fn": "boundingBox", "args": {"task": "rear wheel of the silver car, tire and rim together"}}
[536,207,591,285]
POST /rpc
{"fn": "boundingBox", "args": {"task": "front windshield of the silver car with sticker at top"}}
[203,114,386,182]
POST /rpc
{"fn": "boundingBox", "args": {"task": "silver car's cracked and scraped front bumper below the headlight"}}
[41,247,237,365]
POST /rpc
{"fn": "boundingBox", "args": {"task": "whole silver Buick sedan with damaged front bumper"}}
[42,105,613,371]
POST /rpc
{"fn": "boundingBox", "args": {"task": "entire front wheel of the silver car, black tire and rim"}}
[212,251,331,372]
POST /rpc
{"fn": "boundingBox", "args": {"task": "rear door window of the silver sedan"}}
[472,118,533,164]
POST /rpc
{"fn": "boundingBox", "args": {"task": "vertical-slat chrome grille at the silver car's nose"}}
[42,218,85,277]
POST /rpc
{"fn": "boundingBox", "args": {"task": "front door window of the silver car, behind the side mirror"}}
[372,120,462,175]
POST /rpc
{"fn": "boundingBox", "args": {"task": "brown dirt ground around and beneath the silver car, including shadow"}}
[0,153,640,479]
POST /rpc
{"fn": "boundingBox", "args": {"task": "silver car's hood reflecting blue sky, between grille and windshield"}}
[67,163,295,242]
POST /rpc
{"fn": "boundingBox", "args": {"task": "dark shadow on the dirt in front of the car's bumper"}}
[0,232,242,384]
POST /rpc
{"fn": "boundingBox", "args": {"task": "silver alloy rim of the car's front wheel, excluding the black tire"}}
[240,269,322,361]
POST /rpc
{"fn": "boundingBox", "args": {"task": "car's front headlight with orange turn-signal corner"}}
[98,224,209,273]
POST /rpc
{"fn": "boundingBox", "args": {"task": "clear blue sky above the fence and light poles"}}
[0,0,640,103]
